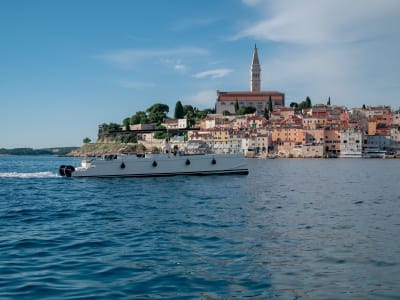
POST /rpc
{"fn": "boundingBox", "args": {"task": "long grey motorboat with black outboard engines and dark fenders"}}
[59,151,249,177]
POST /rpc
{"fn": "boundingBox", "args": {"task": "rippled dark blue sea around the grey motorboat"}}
[0,156,400,300]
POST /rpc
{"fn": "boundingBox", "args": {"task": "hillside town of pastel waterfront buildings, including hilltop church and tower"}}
[98,46,400,158]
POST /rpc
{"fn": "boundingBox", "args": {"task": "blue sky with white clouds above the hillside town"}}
[0,0,400,148]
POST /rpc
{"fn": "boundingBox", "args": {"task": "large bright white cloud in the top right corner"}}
[237,0,400,44]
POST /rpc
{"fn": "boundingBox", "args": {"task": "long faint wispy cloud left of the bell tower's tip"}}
[96,48,209,68]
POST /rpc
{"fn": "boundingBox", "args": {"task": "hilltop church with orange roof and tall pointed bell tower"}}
[215,46,285,115]
